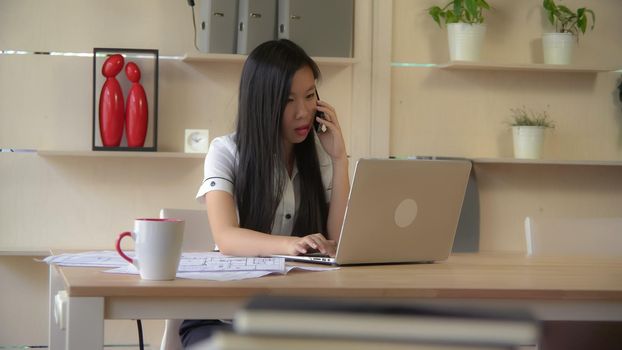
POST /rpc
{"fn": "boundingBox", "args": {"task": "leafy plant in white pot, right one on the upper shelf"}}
[542,0,596,64]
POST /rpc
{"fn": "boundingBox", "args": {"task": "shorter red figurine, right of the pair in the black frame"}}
[125,62,149,147]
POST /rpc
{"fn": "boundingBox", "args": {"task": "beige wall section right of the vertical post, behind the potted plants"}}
[390,0,622,252]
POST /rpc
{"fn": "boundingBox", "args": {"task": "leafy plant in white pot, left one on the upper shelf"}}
[428,0,490,61]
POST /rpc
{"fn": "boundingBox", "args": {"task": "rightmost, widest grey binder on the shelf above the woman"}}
[278,0,354,57]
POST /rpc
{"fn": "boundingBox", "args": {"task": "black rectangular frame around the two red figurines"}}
[91,48,159,152]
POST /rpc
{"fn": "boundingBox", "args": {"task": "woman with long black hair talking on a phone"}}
[180,40,350,346]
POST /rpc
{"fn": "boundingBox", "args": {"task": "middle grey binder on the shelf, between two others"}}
[237,0,277,55]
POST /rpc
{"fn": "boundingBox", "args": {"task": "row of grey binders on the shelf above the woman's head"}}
[196,0,354,57]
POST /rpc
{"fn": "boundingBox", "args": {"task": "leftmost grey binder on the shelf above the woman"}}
[197,0,238,53]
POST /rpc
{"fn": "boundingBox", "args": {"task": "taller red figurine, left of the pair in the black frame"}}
[99,54,125,147]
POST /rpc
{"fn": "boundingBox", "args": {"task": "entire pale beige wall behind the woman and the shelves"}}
[0,0,622,344]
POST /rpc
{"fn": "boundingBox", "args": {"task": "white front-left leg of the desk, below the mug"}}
[66,297,104,350]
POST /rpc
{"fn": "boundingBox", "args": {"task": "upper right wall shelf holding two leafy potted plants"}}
[437,61,619,73]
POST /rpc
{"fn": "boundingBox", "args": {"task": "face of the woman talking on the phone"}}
[281,66,317,145]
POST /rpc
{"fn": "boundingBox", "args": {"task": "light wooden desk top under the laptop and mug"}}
[59,253,622,302]
